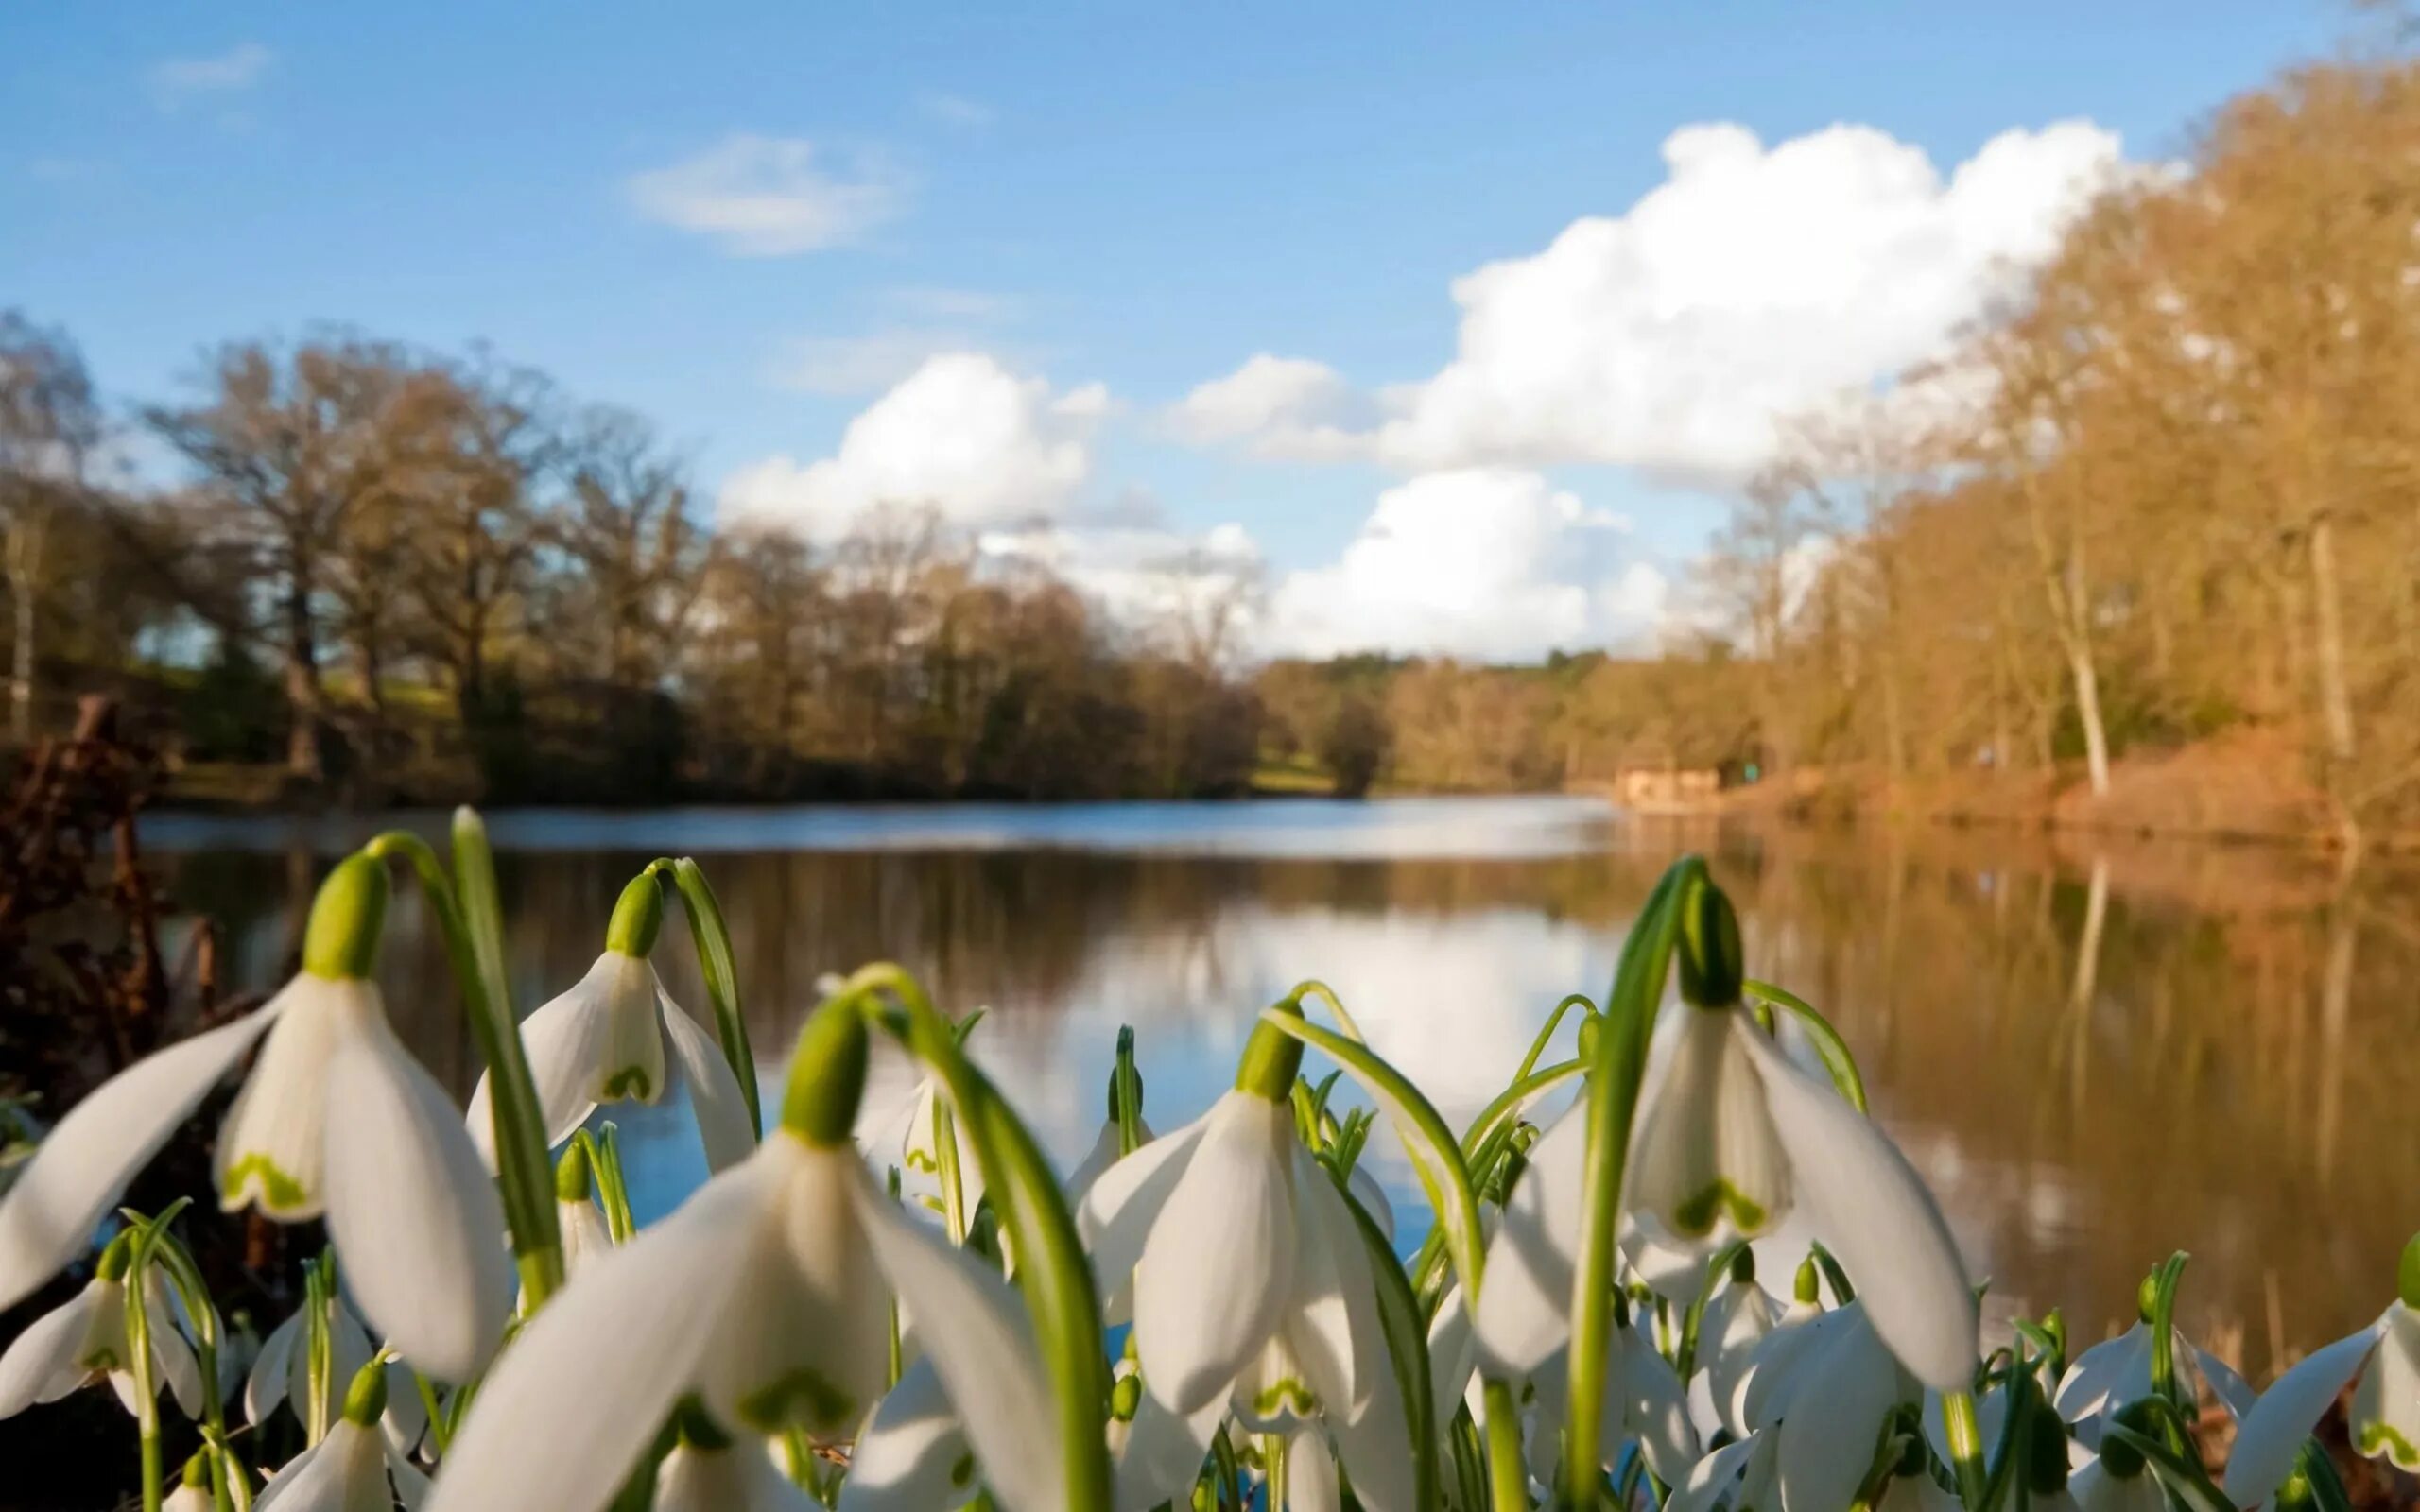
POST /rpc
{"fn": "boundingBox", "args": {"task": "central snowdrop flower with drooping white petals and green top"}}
[1077,1005,1410,1512]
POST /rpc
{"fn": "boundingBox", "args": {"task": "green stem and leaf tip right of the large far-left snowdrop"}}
[363,808,563,1312]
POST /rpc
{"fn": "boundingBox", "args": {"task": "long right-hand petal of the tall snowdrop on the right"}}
[1736,1028,1982,1391]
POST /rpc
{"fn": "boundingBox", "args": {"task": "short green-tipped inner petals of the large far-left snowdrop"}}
[211,975,380,1224]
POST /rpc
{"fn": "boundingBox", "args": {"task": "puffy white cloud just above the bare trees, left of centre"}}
[721,351,1108,540]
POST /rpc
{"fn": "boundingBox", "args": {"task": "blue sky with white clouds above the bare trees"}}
[0,0,2352,653]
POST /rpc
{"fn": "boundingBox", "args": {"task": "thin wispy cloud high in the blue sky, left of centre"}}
[627,133,912,256]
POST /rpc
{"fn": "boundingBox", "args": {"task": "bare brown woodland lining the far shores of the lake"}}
[0,60,2420,834]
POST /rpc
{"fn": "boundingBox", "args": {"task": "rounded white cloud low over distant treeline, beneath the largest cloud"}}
[1268,467,1668,661]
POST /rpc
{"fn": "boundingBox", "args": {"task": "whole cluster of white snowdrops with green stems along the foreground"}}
[0,811,2420,1512]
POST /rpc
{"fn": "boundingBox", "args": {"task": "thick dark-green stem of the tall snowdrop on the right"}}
[1564,856,1713,1512]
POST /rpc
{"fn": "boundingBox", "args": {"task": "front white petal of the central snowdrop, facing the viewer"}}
[1137,1091,1297,1413]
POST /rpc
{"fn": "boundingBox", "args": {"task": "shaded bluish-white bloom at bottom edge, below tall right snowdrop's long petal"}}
[1750,1297,1924,1512]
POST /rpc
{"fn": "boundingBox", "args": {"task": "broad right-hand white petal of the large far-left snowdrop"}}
[327,1016,513,1382]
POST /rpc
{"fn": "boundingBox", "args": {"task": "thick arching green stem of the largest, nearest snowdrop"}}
[847,963,1111,1512]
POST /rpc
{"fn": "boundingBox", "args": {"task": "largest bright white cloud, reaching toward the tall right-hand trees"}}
[1179,121,2122,481]
